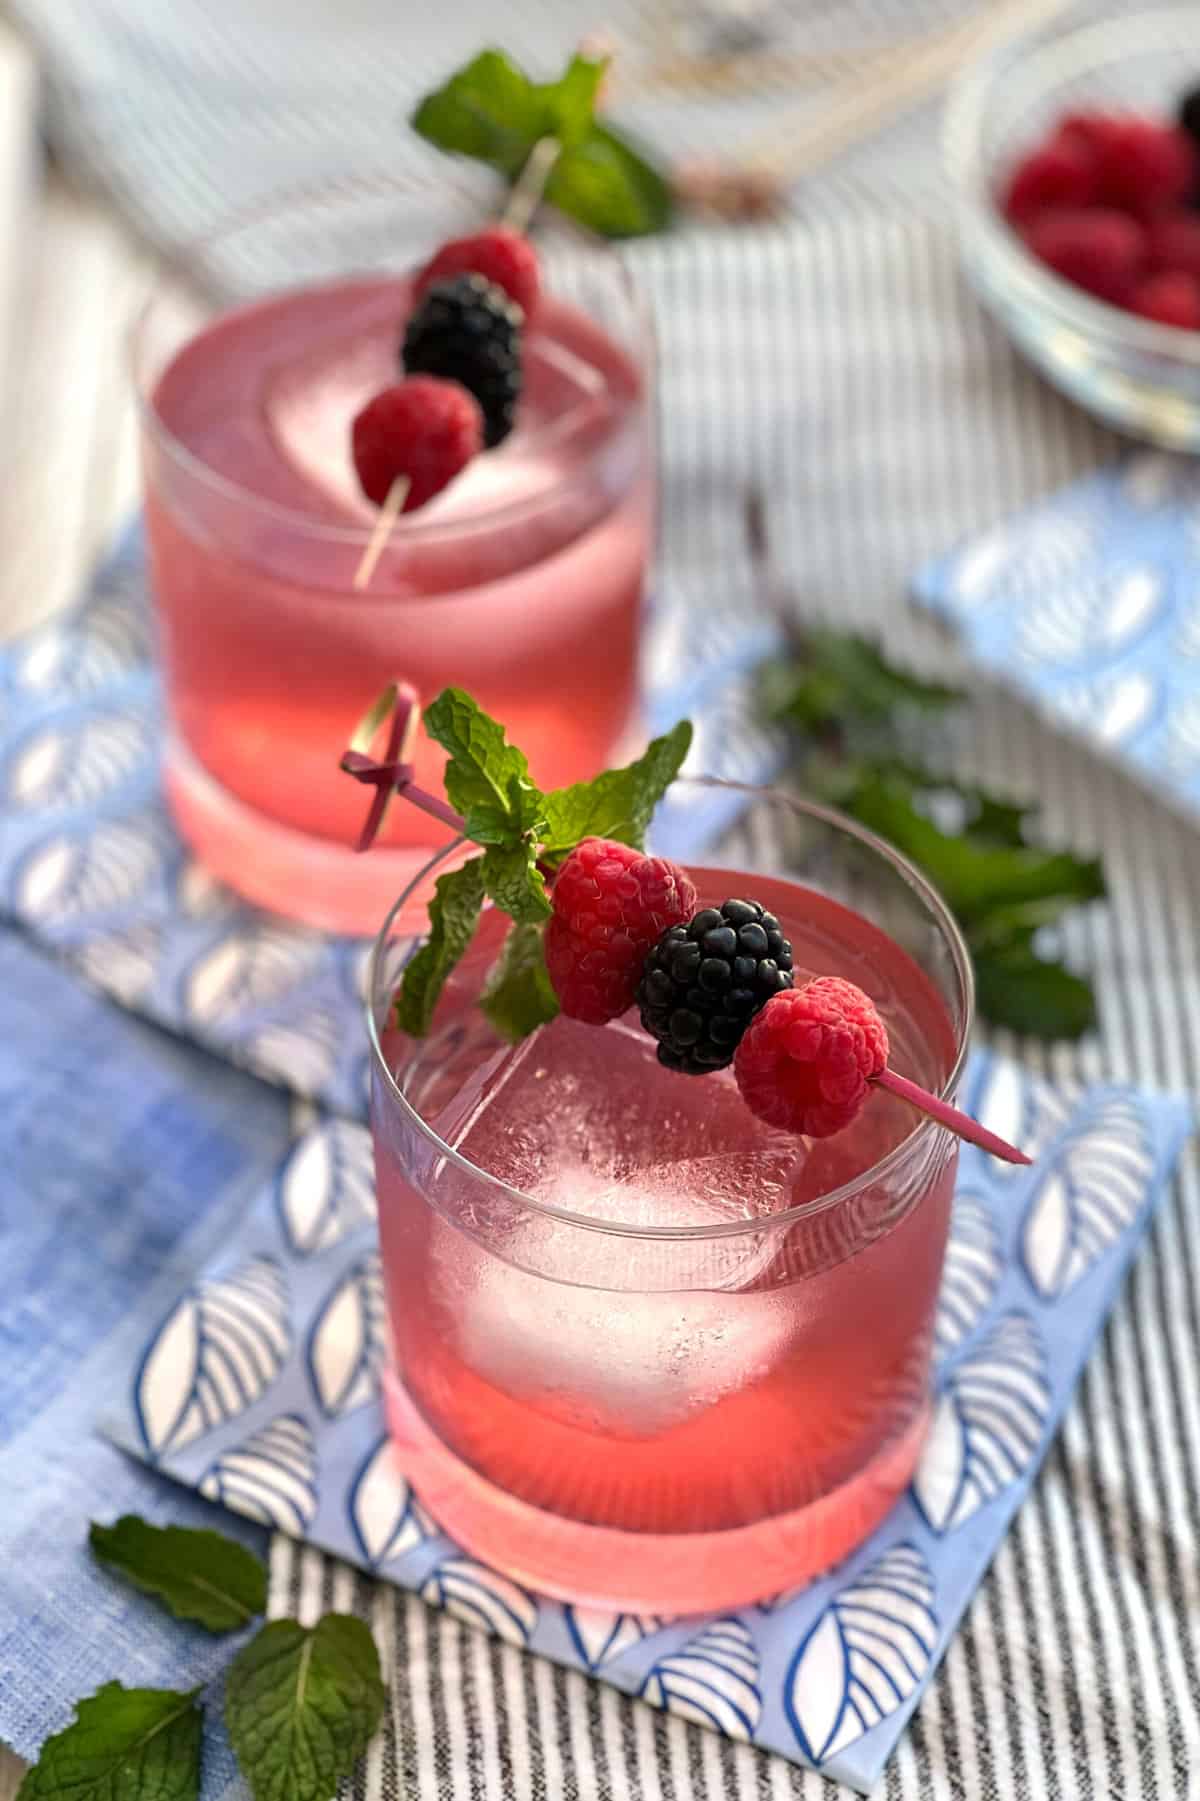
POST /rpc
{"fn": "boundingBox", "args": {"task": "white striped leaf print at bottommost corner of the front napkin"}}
[784,1545,937,1765]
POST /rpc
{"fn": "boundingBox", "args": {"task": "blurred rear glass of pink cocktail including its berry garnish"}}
[135,176,654,935]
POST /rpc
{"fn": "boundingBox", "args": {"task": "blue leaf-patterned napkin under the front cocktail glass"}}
[108,1057,1189,1792]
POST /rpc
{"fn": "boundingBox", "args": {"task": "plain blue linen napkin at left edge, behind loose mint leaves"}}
[0,933,290,1801]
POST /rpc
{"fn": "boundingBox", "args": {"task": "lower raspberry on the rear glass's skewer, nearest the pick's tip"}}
[351,375,483,513]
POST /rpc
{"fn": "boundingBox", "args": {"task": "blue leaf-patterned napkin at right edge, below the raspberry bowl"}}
[915,452,1200,814]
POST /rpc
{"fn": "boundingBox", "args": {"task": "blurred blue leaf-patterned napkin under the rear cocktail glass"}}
[0,531,782,1117]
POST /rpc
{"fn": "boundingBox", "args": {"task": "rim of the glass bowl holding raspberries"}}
[942,5,1200,366]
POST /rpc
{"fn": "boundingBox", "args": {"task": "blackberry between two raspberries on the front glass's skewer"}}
[638,901,791,1075]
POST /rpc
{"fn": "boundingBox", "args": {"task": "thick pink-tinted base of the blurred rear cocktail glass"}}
[162,737,452,938]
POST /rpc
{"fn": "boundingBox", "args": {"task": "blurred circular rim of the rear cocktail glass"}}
[123,171,656,549]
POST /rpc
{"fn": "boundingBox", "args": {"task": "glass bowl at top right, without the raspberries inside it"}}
[944,4,1200,450]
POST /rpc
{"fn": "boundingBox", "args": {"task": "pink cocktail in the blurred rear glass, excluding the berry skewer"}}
[139,191,652,931]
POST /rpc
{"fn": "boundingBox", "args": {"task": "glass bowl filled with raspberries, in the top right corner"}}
[946,0,1200,452]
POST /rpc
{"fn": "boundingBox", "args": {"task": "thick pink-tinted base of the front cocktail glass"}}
[384,1371,932,1614]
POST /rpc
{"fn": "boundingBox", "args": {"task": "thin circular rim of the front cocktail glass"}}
[366,774,975,1243]
